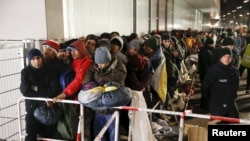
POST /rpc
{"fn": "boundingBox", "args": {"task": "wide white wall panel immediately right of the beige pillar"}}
[63,0,133,39]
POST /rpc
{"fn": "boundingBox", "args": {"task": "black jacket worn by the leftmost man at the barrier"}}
[20,65,61,112]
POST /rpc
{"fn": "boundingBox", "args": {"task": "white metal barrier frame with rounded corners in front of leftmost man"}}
[17,97,84,141]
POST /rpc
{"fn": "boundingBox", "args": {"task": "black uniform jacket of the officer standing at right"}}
[201,61,240,105]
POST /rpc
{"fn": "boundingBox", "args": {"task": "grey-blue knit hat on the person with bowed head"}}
[95,47,111,64]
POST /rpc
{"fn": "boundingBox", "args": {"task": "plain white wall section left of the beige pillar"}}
[0,0,47,40]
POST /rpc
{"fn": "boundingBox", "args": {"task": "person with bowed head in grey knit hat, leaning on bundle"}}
[83,46,127,141]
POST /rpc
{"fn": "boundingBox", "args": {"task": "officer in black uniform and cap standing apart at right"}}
[201,48,240,122]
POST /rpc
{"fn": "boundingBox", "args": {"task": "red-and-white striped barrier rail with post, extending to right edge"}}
[113,106,250,141]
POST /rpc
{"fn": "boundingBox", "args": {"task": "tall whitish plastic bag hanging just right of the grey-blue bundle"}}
[129,90,156,141]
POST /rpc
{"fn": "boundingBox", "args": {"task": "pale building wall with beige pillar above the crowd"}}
[0,0,210,41]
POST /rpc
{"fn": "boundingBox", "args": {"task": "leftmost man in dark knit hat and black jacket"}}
[20,48,61,141]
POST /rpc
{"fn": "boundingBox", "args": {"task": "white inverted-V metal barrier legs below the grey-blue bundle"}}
[94,111,119,141]
